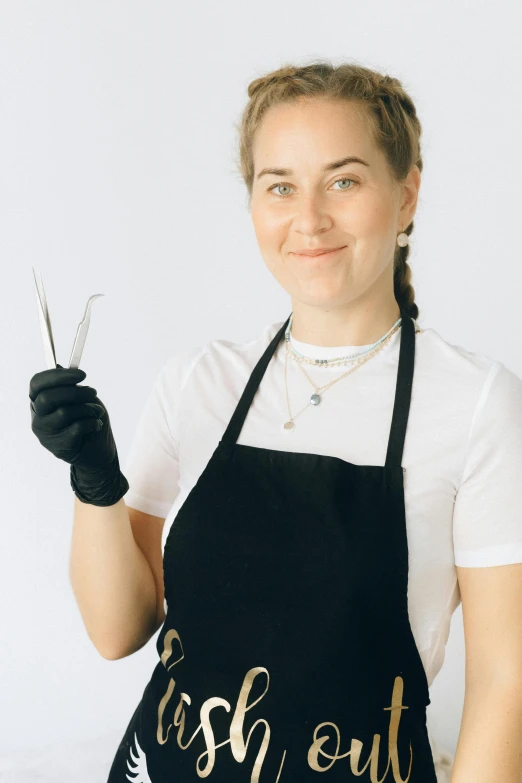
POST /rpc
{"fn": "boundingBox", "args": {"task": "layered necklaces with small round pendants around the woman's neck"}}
[282,315,402,433]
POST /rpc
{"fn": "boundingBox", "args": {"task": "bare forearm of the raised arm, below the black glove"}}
[69,496,156,659]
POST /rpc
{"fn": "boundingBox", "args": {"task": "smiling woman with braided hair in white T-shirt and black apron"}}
[31,63,522,783]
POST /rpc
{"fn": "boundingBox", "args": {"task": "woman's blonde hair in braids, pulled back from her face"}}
[235,60,422,319]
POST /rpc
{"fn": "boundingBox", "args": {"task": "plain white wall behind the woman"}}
[0,0,522,780]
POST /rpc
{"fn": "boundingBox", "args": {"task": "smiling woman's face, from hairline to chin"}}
[251,99,420,306]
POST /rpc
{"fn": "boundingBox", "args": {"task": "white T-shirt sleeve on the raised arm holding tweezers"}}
[122,347,202,518]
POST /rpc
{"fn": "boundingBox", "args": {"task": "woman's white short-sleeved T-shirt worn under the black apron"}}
[121,318,522,685]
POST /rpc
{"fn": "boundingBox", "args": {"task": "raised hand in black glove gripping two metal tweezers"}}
[29,364,129,506]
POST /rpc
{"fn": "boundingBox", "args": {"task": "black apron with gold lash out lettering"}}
[108,310,437,783]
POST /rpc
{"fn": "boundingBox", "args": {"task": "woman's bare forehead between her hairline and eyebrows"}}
[253,98,379,169]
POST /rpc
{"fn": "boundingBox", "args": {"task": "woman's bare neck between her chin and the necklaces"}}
[286,298,401,347]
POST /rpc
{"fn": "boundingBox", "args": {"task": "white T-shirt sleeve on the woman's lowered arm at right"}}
[453,362,522,568]
